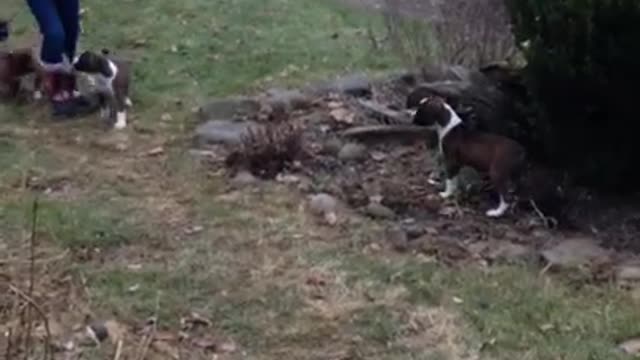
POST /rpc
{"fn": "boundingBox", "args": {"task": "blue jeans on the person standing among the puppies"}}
[27,0,80,65]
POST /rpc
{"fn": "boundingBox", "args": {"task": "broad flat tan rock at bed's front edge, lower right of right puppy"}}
[541,238,610,268]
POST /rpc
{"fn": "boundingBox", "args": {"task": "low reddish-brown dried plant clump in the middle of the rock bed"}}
[225,123,304,179]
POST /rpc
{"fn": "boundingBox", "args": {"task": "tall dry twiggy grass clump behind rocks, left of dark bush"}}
[385,0,517,69]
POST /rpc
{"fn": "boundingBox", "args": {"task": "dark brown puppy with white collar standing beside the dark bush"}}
[413,96,526,217]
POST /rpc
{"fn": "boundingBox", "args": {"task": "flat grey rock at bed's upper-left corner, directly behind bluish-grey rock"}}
[198,97,261,121]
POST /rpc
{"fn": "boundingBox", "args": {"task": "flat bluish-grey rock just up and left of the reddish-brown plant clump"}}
[195,120,259,145]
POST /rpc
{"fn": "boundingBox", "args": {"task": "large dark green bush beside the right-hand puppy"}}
[506,0,640,190]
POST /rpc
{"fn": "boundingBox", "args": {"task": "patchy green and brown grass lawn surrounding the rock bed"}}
[0,0,640,360]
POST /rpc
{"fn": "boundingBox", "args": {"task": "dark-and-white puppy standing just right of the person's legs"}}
[73,50,132,129]
